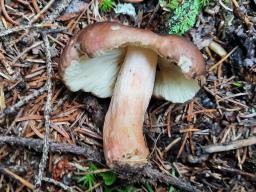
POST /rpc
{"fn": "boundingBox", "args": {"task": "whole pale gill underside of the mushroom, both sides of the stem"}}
[64,48,200,103]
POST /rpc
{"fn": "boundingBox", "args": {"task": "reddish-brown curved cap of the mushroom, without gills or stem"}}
[59,22,205,96]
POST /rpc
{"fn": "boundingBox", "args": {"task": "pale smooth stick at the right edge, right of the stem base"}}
[203,136,256,153]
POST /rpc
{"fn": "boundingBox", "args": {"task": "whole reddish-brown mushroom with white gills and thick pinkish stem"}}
[60,22,205,167]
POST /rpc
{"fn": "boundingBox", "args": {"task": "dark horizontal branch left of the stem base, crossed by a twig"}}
[0,136,103,163]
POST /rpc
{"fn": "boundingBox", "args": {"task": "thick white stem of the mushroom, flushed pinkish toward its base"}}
[103,47,157,166]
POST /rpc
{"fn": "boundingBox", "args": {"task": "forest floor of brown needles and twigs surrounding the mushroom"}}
[0,0,256,192]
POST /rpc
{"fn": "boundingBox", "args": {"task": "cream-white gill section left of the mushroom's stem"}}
[64,49,125,98]
